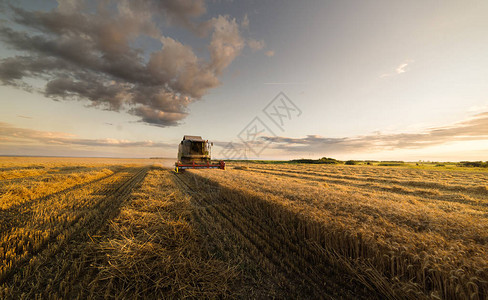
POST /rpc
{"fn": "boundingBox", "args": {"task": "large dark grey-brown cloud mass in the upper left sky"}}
[0,0,244,126]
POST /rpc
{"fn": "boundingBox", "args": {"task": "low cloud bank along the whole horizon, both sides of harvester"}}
[0,112,488,157]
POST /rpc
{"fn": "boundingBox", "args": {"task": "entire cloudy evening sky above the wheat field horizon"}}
[0,0,488,161]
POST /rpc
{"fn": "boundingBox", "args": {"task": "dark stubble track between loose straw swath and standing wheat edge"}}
[174,172,374,299]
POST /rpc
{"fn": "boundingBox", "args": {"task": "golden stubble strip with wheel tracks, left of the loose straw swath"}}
[0,167,148,298]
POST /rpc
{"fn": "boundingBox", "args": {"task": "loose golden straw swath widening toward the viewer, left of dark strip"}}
[88,168,237,299]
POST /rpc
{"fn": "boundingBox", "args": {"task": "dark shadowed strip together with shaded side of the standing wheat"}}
[176,172,488,299]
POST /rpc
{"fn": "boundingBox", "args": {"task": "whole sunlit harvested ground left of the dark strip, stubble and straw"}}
[0,165,239,299]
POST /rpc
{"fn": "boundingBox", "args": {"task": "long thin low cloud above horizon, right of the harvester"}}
[262,112,488,153]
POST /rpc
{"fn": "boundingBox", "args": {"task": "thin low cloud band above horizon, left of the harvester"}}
[0,122,174,148]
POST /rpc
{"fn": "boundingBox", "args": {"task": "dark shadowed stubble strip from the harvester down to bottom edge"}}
[177,172,382,299]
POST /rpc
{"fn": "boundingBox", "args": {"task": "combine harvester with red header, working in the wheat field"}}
[175,135,225,173]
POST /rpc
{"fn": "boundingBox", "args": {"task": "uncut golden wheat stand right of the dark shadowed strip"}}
[195,165,488,299]
